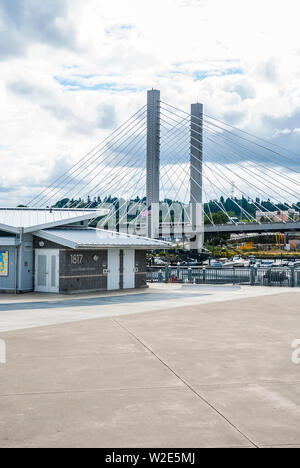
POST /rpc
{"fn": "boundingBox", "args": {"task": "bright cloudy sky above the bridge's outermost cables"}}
[0,0,300,205]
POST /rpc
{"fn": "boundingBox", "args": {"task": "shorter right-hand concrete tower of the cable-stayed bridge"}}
[190,103,204,253]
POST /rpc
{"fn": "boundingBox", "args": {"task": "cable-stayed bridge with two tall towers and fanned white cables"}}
[29,90,300,250]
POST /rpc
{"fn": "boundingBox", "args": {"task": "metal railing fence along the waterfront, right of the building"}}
[147,267,300,287]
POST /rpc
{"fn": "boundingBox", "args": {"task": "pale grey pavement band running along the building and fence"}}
[0,284,300,333]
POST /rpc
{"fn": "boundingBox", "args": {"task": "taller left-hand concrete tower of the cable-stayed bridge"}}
[147,89,160,238]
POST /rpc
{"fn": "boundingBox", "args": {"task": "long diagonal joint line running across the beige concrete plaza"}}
[112,318,259,448]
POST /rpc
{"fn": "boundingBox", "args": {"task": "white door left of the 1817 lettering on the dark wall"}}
[35,249,59,293]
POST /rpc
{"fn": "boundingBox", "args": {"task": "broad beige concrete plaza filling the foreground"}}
[0,288,300,448]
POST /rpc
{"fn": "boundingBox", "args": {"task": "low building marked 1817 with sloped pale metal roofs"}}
[0,209,170,294]
